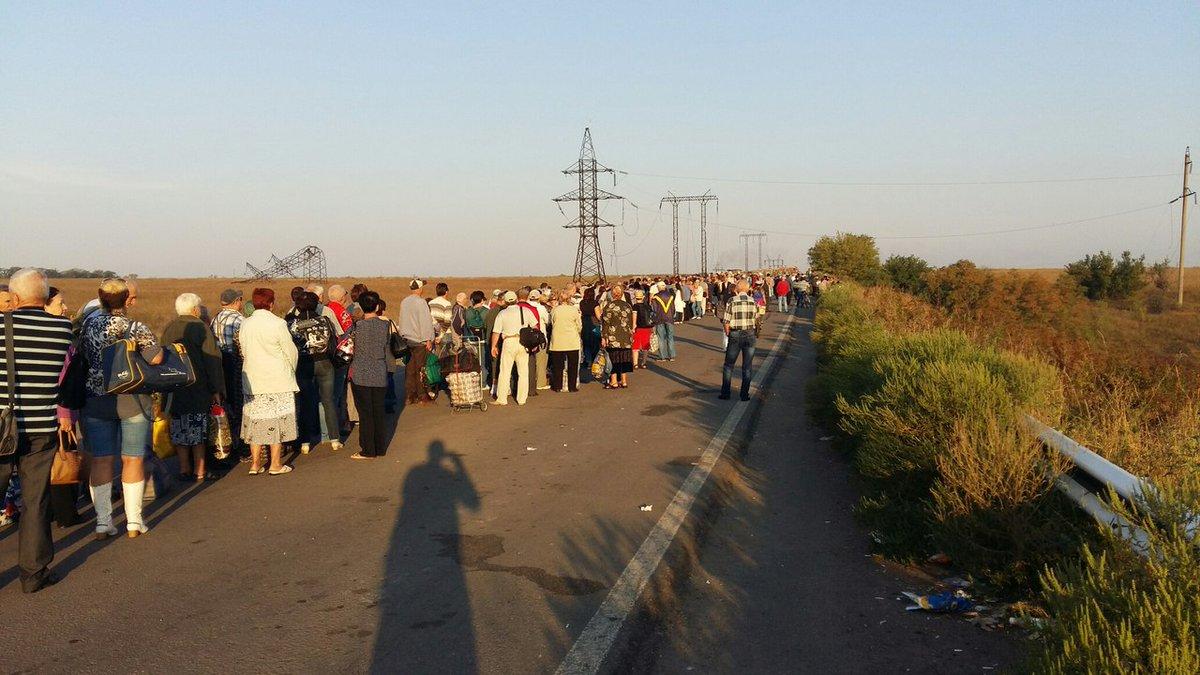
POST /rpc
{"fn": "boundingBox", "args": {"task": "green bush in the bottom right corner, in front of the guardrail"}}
[1034,476,1200,674]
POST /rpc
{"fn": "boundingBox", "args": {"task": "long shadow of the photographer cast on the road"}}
[371,441,477,673]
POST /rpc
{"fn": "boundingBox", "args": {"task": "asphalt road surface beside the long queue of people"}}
[0,313,1010,673]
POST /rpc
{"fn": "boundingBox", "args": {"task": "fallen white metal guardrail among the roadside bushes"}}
[1025,416,1154,555]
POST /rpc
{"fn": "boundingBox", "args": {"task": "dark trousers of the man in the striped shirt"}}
[0,432,59,592]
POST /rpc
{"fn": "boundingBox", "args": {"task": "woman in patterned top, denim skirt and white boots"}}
[79,279,163,539]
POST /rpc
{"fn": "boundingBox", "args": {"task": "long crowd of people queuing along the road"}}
[0,269,832,592]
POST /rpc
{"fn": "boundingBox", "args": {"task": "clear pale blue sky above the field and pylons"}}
[0,0,1200,276]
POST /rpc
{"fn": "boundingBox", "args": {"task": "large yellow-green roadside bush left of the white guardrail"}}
[810,285,1062,590]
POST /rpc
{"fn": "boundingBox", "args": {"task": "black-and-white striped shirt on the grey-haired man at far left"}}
[0,307,73,434]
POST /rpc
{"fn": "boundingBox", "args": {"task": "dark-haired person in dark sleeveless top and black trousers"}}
[350,291,396,460]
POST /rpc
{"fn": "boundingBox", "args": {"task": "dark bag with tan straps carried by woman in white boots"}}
[100,323,196,394]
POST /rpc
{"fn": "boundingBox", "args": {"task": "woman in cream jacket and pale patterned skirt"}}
[238,288,300,476]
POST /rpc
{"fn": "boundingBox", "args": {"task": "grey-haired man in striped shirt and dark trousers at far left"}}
[0,269,74,593]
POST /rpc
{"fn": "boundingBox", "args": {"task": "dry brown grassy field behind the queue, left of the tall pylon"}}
[53,276,580,333]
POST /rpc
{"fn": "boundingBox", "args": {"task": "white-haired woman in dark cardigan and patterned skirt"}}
[162,293,224,483]
